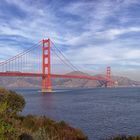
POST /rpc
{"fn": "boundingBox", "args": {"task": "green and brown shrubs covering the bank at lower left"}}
[0,88,87,140]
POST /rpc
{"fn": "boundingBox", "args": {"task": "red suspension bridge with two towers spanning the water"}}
[0,39,114,92]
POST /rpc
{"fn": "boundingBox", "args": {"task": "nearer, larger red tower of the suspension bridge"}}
[42,39,52,92]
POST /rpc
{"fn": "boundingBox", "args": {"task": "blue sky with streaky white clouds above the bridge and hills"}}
[0,0,140,80]
